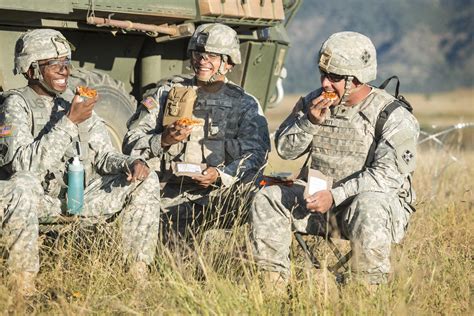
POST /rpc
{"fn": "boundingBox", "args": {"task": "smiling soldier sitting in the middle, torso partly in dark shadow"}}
[124,23,270,237]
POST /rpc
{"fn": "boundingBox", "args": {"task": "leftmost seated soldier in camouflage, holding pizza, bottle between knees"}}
[0,29,160,290]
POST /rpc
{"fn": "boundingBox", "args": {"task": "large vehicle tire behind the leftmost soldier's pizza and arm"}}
[69,68,137,152]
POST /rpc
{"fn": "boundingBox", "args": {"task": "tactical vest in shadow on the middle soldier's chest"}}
[164,83,244,171]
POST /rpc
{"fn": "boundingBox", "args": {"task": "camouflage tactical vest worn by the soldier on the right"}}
[311,87,391,185]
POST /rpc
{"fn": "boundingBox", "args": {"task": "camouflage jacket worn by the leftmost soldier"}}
[0,87,134,196]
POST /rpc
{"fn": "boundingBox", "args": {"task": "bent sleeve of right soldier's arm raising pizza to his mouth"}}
[275,95,319,159]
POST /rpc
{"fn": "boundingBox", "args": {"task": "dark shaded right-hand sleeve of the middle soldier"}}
[218,96,270,186]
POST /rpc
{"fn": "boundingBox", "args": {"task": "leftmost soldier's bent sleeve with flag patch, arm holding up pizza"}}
[1,95,78,173]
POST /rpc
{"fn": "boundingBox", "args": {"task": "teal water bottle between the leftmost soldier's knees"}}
[67,157,84,215]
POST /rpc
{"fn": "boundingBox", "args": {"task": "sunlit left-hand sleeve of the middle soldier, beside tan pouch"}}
[123,87,168,160]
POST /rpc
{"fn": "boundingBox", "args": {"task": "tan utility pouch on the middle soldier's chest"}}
[163,87,197,126]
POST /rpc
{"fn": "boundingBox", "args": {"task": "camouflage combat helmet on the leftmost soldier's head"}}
[13,29,71,75]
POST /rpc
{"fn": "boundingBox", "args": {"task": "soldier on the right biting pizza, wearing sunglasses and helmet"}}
[250,32,419,284]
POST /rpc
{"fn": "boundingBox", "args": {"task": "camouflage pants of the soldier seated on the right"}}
[250,181,410,283]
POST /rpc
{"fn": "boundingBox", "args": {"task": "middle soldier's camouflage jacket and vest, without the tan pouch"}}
[124,76,270,186]
